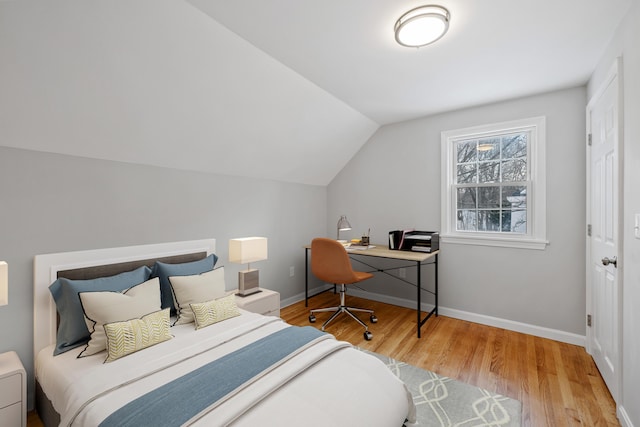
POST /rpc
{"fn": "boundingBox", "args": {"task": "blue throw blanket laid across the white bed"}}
[100,326,324,427]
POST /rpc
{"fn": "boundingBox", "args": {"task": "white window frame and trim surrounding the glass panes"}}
[440,116,549,250]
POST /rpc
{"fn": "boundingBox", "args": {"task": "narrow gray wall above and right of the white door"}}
[588,2,640,426]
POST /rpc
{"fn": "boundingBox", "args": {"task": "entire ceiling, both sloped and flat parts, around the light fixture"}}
[0,0,633,185]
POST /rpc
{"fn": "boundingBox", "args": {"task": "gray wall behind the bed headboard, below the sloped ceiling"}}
[0,147,326,407]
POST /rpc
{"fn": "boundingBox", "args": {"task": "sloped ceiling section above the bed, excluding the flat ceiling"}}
[0,0,378,185]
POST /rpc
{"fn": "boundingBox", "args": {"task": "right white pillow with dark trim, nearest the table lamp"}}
[169,267,225,325]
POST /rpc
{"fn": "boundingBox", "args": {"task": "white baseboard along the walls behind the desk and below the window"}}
[281,285,586,347]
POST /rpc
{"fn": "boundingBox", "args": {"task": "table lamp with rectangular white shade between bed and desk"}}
[229,237,267,297]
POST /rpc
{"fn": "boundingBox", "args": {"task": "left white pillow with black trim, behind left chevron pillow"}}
[78,277,160,357]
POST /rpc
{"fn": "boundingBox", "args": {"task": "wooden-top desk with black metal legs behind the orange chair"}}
[304,244,440,338]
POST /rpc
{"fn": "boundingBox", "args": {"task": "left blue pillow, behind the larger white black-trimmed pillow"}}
[49,266,151,356]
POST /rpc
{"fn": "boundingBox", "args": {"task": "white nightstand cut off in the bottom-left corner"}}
[0,351,27,427]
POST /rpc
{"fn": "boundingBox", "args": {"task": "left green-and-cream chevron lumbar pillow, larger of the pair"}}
[104,308,173,362]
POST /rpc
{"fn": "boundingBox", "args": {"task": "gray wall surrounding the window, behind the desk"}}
[328,87,586,336]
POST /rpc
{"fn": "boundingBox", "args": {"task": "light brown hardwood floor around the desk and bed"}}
[27,292,620,427]
